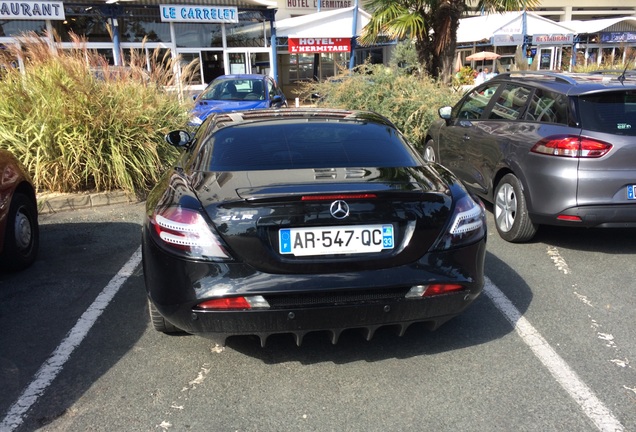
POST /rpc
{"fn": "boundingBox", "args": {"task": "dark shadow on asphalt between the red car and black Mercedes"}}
[0,219,148,430]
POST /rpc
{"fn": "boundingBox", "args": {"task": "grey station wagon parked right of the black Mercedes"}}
[424,72,636,242]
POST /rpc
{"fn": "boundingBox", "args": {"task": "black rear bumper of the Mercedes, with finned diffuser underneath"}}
[142,228,486,345]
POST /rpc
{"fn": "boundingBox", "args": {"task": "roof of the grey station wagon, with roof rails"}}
[491,70,636,96]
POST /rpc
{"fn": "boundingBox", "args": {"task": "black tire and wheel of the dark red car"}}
[1,192,40,271]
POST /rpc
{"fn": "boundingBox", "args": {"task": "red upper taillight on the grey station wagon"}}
[530,135,612,158]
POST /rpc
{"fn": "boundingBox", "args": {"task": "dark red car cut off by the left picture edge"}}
[0,149,40,271]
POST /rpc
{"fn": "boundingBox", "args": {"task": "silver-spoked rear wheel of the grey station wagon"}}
[494,174,537,243]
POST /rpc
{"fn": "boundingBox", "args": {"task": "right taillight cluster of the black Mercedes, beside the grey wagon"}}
[436,195,486,249]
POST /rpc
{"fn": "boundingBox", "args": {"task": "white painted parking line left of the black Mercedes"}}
[0,247,141,432]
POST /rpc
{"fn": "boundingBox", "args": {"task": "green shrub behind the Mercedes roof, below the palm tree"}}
[302,64,460,148]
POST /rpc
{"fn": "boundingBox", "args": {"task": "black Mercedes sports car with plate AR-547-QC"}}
[142,108,486,345]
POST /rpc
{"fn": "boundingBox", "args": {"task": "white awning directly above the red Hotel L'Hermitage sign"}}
[276,7,371,38]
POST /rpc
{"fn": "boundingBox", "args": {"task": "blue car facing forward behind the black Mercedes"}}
[190,74,287,125]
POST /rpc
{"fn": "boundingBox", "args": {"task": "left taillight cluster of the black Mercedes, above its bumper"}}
[150,207,230,260]
